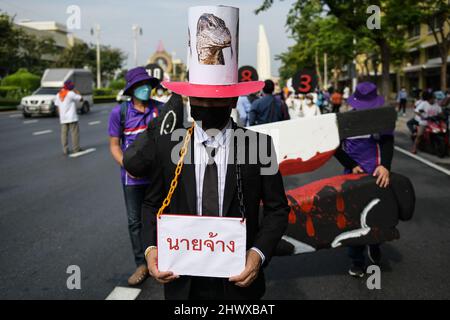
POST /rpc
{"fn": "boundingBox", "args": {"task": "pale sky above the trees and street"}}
[0,0,294,76]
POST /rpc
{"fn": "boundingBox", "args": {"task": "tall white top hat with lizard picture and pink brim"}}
[163,6,264,98]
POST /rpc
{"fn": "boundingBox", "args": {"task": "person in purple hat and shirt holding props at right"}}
[335,82,394,277]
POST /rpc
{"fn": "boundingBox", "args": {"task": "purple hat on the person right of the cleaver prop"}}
[347,82,384,110]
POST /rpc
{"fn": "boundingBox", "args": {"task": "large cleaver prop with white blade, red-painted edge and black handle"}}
[250,107,396,176]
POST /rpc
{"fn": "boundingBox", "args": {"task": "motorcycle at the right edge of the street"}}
[411,116,450,158]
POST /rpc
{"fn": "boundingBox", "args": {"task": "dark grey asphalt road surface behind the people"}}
[0,105,450,299]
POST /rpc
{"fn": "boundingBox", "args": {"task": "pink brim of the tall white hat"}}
[162,81,264,98]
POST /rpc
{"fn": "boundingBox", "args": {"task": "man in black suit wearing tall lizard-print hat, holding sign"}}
[124,6,290,299]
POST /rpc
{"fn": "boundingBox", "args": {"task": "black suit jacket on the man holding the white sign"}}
[138,122,290,300]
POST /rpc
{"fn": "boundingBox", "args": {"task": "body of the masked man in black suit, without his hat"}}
[138,97,290,300]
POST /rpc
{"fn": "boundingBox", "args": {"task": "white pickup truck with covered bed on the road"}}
[19,69,94,118]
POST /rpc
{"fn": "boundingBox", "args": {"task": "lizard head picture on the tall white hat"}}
[196,13,233,65]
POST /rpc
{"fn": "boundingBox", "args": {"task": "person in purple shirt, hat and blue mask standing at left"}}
[108,67,163,286]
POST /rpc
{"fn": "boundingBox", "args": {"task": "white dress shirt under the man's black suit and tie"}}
[194,120,265,264]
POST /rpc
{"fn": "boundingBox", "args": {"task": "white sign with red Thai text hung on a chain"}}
[157,214,247,278]
